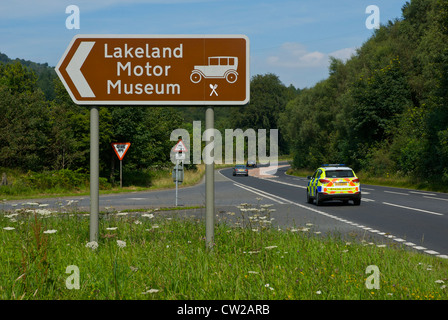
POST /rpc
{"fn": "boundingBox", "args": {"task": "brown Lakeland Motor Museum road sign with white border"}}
[56,35,250,105]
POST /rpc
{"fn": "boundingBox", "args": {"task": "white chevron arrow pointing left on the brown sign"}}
[66,41,95,98]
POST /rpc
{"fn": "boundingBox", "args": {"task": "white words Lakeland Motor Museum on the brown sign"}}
[104,43,183,95]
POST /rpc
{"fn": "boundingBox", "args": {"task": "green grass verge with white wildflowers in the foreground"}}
[0,205,448,300]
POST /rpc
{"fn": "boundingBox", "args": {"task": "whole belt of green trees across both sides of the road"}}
[0,0,448,190]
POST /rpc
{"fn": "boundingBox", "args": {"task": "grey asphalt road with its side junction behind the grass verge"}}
[0,163,448,258]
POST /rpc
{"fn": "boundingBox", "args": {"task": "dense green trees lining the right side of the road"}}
[280,0,448,183]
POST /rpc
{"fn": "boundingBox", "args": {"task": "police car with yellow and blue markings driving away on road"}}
[306,164,361,206]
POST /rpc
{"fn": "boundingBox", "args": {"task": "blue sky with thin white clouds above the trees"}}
[0,0,406,88]
